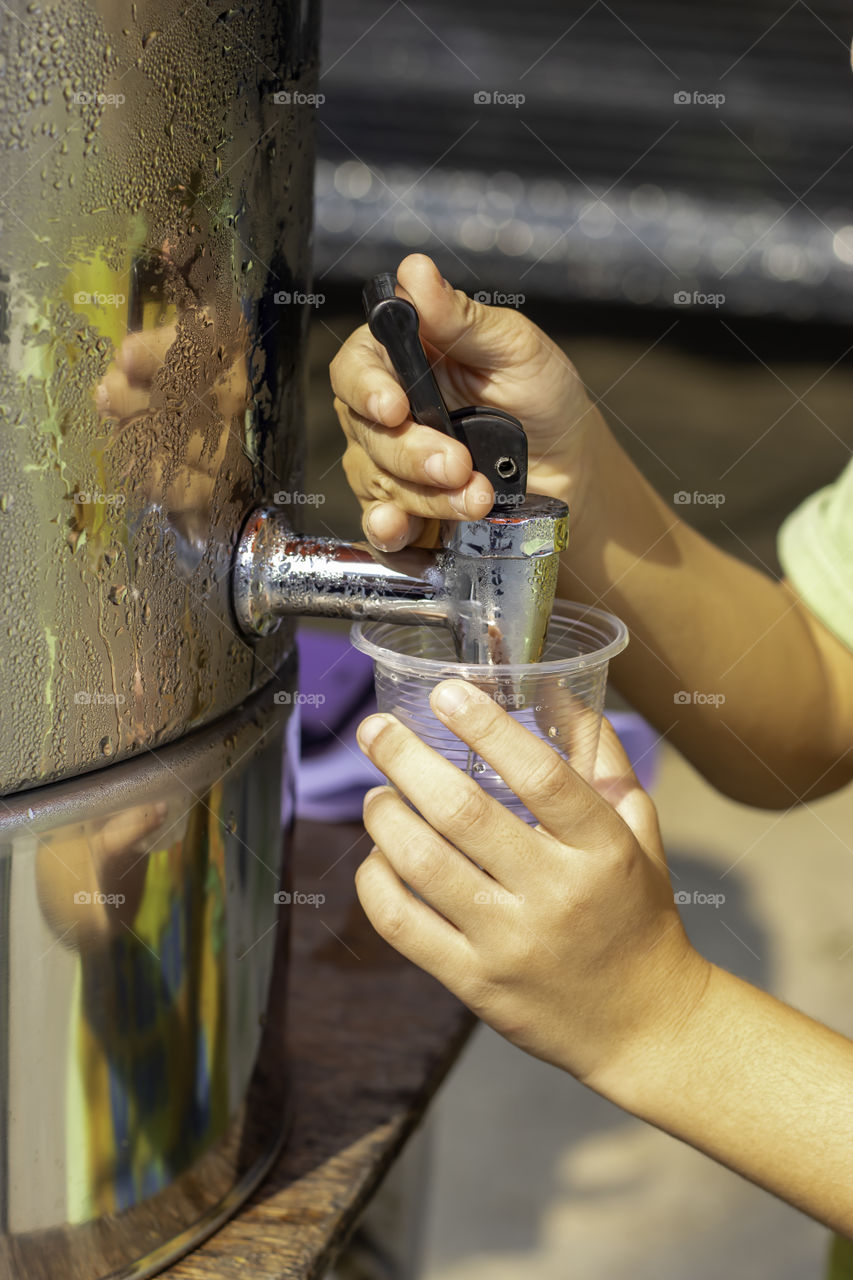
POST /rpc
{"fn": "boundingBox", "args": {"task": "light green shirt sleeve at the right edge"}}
[777,460,853,649]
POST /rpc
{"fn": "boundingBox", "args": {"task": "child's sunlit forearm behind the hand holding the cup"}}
[587,968,853,1236]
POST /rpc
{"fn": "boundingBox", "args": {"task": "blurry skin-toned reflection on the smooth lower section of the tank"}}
[36,803,168,951]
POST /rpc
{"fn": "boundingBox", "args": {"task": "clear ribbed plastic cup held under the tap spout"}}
[351,600,628,823]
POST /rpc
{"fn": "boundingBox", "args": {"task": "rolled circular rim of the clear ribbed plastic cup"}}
[350,600,629,680]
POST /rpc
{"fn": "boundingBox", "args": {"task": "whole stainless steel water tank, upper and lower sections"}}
[0,0,318,1280]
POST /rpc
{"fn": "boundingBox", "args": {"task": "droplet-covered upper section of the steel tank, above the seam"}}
[0,0,318,794]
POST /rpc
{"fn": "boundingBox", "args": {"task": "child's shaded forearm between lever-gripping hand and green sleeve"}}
[558,429,853,808]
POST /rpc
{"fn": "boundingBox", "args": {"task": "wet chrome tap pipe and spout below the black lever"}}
[233,494,569,663]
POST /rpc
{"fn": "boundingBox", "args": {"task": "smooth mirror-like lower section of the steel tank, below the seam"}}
[0,660,295,1280]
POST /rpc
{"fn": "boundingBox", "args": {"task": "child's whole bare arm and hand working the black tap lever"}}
[332,253,853,806]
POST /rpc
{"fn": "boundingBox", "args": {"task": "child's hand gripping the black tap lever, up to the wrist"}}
[330,253,603,550]
